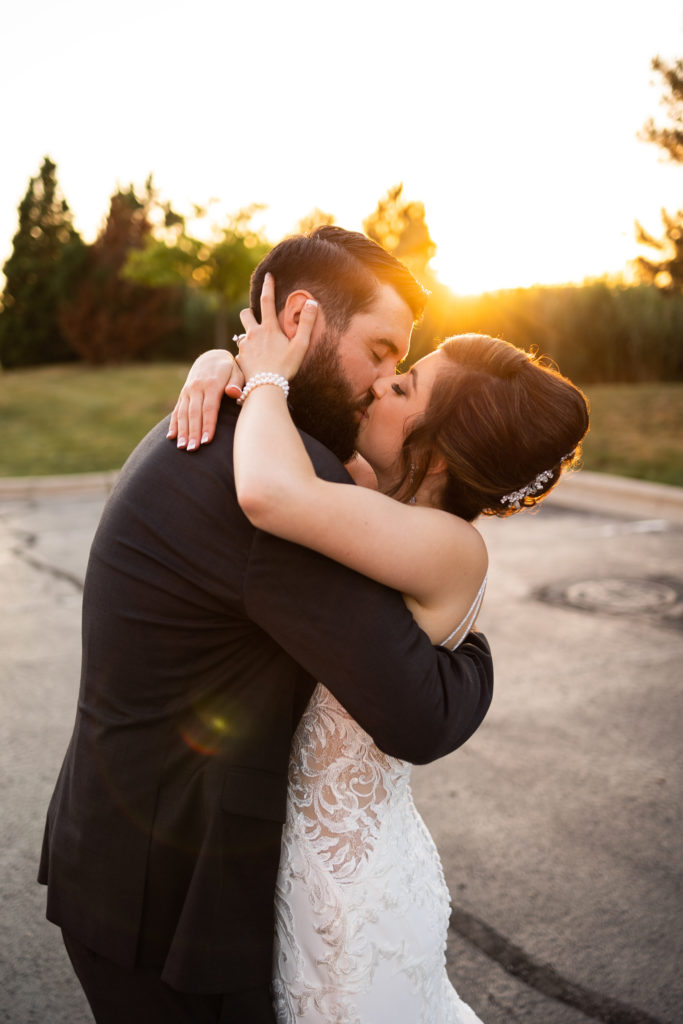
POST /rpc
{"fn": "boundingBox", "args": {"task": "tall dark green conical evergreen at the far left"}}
[0,157,85,369]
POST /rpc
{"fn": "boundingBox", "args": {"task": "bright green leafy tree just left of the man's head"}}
[123,205,269,348]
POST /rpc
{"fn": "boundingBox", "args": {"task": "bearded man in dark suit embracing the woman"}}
[39,227,492,1024]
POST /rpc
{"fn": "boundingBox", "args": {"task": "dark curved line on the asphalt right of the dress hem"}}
[450,906,665,1024]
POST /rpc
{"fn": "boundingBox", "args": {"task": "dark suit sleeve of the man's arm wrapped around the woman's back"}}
[244,432,493,764]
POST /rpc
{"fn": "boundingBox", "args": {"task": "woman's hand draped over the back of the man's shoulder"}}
[166,348,245,452]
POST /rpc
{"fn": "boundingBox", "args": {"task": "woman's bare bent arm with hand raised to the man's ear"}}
[234,280,486,614]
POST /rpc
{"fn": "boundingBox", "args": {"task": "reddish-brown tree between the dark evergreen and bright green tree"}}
[59,178,180,364]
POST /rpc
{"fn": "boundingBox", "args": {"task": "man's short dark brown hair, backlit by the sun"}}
[250,225,428,331]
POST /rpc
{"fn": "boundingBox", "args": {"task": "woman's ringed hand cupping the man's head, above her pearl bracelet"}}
[238,273,317,381]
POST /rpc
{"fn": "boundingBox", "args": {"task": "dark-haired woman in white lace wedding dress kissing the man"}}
[171,275,588,1024]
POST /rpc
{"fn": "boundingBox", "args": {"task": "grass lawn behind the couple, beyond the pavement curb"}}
[0,364,683,486]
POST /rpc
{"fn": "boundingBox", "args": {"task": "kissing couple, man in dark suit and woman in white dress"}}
[39,226,588,1024]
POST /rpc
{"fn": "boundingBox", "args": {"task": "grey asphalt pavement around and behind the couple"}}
[0,474,683,1024]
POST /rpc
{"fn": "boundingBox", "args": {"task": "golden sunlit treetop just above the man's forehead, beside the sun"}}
[362,183,436,282]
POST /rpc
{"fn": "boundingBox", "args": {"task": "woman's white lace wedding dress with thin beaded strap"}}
[273,581,485,1024]
